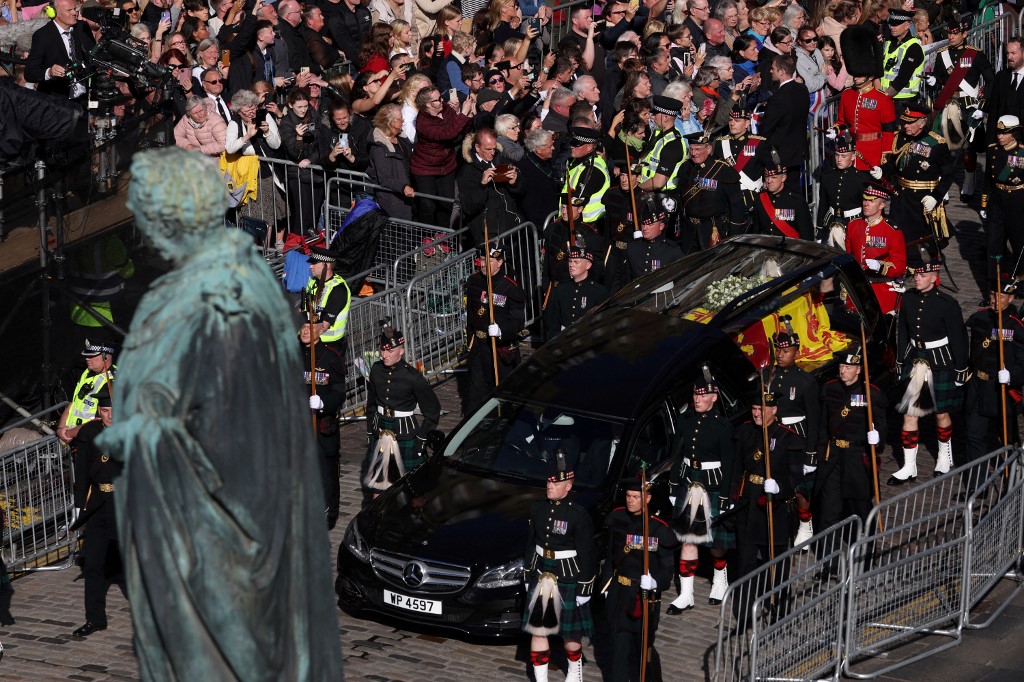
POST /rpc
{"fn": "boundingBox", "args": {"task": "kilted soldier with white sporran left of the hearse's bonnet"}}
[362,324,441,493]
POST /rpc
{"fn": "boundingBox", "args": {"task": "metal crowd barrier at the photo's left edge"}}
[0,402,77,571]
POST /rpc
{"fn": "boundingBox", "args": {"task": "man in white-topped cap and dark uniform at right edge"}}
[981,116,1024,294]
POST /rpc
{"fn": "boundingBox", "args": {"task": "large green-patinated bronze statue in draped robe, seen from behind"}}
[97,147,341,682]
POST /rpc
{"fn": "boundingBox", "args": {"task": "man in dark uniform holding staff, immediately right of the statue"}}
[299,312,345,530]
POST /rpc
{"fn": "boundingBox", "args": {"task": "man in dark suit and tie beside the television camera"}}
[25,0,91,99]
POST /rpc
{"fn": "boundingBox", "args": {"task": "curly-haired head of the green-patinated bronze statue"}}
[128,146,227,263]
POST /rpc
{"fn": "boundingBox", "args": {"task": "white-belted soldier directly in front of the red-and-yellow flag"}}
[770,315,821,548]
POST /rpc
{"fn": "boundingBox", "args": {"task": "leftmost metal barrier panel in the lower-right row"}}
[713,516,861,682]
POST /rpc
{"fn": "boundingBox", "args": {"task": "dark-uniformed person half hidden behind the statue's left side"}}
[71,387,124,637]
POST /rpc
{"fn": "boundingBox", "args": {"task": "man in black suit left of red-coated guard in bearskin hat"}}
[758,54,811,189]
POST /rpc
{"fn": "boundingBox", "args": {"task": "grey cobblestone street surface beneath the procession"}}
[0,186,1024,682]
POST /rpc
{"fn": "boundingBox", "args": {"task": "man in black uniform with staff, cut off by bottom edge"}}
[598,478,679,682]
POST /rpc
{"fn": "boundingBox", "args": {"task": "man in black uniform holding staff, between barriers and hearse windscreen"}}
[465,247,526,415]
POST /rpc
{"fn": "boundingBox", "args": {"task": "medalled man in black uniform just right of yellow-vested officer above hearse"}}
[679,131,748,253]
